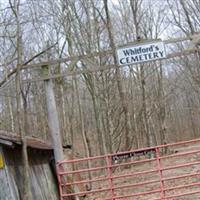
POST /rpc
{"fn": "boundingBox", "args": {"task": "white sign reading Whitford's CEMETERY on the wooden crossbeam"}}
[117,41,166,65]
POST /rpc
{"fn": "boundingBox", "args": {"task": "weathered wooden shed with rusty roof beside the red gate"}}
[0,131,59,200]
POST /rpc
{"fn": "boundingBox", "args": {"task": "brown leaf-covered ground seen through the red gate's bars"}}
[64,141,200,200]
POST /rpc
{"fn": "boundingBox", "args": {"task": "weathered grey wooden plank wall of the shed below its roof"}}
[0,146,59,200]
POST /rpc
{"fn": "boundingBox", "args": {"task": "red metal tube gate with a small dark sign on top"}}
[57,139,200,200]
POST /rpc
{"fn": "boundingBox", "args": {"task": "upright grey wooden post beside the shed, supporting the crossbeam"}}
[42,65,64,162]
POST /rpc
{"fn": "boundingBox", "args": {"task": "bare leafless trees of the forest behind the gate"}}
[0,0,200,157]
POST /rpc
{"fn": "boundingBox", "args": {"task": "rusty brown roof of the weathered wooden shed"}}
[0,130,53,150]
